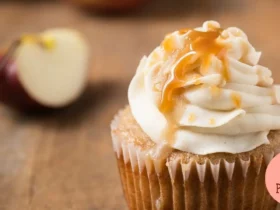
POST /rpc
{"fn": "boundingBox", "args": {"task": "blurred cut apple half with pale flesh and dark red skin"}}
[0,28,89,111]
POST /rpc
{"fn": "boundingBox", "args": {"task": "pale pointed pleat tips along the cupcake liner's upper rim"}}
[112,132,280,183]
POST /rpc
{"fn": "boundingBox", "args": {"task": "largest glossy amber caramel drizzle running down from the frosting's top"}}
[160,29,226,113]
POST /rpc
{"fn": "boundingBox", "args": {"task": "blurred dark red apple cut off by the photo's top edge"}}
[64,0,148,12]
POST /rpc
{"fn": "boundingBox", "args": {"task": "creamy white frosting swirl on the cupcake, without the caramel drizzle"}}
[128,21,280,155]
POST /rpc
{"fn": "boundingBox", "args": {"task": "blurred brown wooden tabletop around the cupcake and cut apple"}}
[0,0,280,210]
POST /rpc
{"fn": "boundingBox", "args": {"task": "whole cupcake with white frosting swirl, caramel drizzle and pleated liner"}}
[111,21,280,210]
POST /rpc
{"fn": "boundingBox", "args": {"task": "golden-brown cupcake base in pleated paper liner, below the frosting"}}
[112,107,280,210]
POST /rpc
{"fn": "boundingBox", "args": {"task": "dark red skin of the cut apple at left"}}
[0,55,45,112]
